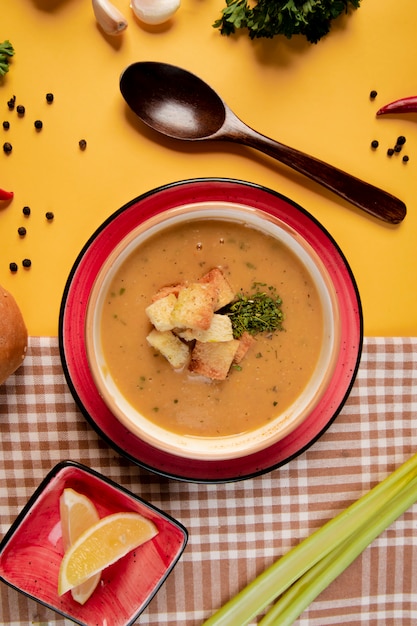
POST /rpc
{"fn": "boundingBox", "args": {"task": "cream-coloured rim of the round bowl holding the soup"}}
[85,202,340,461]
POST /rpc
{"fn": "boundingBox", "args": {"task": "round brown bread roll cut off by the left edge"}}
[0,285,28,385]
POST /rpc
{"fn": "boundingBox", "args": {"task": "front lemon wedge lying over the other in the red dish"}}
[58,513,158,596]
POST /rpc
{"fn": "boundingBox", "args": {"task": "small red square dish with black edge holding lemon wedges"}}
[0,461,188,626]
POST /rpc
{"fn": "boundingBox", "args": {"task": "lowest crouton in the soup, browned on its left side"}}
[188,339,239,380]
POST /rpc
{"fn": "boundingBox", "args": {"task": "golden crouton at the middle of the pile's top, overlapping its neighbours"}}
[171,283,217,330]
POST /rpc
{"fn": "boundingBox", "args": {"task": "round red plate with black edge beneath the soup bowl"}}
[59,178,363,482]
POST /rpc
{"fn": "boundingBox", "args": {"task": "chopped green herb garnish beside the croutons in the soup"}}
[222,283,284,339]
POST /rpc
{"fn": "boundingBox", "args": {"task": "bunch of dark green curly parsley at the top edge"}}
[213,0,360,43]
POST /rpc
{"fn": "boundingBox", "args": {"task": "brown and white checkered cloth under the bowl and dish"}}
[0,337,417,626]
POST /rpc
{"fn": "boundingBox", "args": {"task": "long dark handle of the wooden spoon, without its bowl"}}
[229,120,407,224]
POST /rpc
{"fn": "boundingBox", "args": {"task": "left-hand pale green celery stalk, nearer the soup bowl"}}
[203,454,417,626]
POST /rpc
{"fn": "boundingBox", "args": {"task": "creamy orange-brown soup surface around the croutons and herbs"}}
[101,219,323,437]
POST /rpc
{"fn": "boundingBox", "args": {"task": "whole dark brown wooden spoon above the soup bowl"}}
[120,61,407,224]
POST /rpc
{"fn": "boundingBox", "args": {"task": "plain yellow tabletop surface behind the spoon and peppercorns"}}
[0,0,417,336]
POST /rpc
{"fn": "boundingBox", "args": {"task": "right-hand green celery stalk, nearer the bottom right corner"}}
[259,478,417,626]
